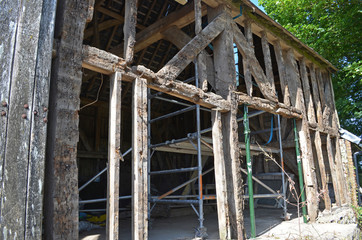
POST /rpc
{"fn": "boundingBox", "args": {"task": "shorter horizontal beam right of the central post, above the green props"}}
[235,92,302,119]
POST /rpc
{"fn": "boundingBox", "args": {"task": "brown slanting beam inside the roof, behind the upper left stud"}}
[111,4,206,56]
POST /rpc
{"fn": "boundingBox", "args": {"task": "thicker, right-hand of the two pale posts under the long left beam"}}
[132,78,148,240]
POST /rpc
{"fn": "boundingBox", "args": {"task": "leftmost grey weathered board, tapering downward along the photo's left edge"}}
[0,0,20,212]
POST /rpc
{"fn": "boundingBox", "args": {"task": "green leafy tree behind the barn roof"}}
[259,0,362,136]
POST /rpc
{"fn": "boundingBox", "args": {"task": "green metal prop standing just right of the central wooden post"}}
[244,105,256,238]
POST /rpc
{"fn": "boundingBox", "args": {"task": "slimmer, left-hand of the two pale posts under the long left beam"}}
[106,72,122,240]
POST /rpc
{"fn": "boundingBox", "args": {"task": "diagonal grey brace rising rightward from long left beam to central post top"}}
[157,14,226,80]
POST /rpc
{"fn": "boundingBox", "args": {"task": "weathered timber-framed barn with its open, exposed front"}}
[0,0,356,239]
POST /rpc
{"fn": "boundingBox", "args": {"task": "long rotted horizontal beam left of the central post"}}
[82,46,230,112]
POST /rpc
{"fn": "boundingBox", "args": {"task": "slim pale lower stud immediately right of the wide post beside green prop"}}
[314,131,332,211]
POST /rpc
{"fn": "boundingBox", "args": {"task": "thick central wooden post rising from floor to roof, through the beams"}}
[208,5,244,239]
